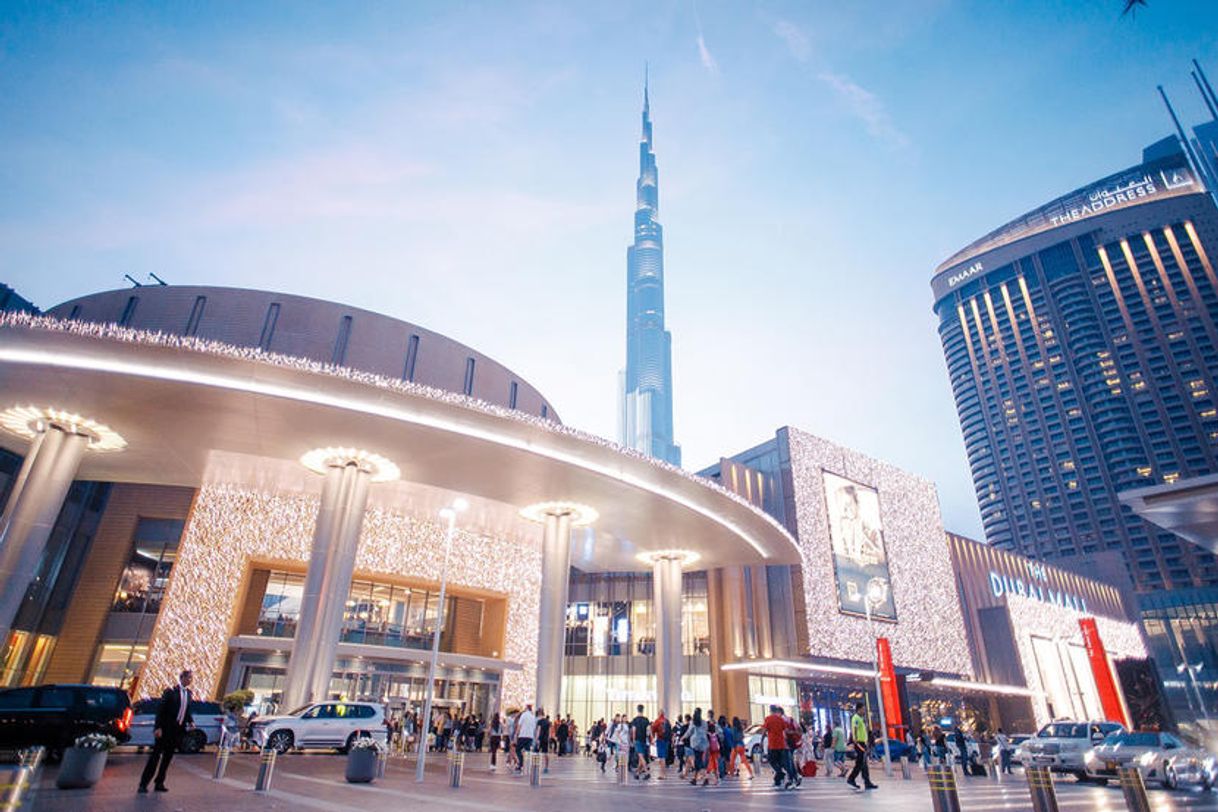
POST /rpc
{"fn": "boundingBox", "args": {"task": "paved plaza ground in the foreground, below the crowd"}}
[22,752,1218,812]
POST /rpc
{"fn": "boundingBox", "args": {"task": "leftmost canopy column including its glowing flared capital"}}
[0,407,127,642]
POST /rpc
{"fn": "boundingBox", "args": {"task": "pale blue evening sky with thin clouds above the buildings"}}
[0,0,1218,538]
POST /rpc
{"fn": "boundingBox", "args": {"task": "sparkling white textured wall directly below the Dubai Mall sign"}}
[1006,595,1149,724]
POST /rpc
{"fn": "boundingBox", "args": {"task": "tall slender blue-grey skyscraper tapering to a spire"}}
[619,80,681,465]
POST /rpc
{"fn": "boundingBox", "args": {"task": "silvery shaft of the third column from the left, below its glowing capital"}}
[535,510,571,716]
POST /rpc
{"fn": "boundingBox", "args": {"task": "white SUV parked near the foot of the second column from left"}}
[250,702,385,752]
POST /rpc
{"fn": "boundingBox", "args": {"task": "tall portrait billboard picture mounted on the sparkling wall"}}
[822,471,896,621]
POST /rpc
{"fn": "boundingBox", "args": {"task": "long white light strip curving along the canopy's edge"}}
[0,347,798,559]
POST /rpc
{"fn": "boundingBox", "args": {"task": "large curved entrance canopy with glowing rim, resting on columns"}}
[0,314,799,571]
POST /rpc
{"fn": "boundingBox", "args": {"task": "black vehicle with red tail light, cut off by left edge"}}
[0,685,132,760]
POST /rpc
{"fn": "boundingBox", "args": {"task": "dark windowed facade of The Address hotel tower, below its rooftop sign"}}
[935,206,1218,592]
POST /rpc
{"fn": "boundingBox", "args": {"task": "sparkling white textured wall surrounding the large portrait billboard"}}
[787,429,972,677]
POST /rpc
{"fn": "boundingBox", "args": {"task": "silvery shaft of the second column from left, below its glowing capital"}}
[283,460,371,711]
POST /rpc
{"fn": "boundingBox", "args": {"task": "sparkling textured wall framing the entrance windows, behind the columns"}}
[143,485,541,706]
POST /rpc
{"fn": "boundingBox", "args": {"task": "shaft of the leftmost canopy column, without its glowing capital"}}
[0,422,93,645]
